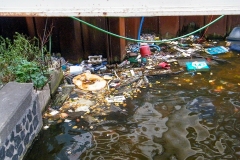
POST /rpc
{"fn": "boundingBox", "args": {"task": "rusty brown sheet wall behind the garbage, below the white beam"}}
[0,15,240,62]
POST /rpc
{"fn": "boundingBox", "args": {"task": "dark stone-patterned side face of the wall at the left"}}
[0,93,42,160]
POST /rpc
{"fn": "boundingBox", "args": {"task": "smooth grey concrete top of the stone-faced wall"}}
[0,82,33,145]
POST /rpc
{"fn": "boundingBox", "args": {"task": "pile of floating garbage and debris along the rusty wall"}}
[44,35,232,130]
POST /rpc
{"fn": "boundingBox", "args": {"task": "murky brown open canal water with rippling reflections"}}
[24,48,240,160]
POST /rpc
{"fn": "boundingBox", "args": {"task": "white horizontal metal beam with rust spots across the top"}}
[0,0,240,17]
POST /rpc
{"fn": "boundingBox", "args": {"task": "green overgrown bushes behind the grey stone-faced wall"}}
[0,33,51,89]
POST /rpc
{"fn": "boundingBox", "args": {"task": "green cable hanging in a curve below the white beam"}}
[70,15,224,43]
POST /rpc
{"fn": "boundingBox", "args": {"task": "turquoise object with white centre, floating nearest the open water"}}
[186,61,210,71]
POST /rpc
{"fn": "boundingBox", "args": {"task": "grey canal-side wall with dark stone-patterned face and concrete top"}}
[0,82,42,160]
